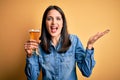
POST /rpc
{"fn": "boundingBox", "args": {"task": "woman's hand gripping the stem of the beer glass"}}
[24,40,39,57]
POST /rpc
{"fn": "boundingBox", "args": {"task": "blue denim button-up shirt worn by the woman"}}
[25,35,95,80]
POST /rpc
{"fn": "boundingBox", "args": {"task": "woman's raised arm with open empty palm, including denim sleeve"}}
[76,29,110,77]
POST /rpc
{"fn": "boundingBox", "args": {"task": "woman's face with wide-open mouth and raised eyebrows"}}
[46,9,63,37]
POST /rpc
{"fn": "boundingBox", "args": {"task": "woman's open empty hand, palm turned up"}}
[87,29,110,49]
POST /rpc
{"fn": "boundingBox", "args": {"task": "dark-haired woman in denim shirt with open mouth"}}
[24,6,109,80]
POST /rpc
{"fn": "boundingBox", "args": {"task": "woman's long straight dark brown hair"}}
[40,5,71,53]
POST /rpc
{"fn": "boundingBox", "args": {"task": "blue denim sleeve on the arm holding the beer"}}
[25,53,40,80]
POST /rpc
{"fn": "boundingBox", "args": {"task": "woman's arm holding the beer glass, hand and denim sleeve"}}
[24,40,40,80]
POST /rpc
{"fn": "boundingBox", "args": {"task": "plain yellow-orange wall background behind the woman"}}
[0,0,120,80]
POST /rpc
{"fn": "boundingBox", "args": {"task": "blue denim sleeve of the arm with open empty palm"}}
[75,37,95,77]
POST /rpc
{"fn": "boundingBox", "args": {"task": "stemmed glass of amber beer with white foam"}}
[29,29,40,55]
